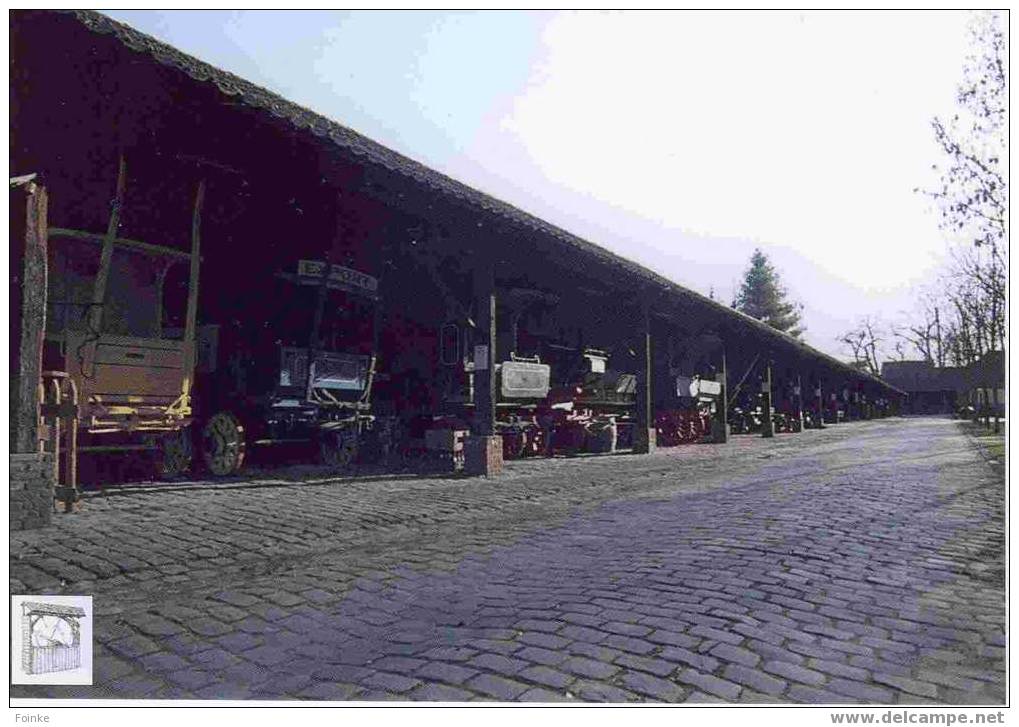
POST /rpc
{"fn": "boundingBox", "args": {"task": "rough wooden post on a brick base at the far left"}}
[10,183,47,453]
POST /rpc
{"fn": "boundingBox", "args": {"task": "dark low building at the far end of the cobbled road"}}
[881,351,1005,414]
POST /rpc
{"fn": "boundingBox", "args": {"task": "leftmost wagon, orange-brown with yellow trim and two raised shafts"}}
[46,159,205,476]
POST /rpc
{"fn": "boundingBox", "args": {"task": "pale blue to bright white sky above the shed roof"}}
[107,10,968,358]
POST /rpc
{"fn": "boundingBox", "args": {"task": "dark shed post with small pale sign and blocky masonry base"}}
[464,256,502,476]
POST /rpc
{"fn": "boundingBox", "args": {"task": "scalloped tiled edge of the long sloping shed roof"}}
[61,10,903,394]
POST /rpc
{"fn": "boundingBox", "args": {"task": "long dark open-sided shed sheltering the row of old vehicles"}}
[10,11,901,477]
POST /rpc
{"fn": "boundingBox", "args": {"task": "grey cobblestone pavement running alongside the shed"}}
[10,418,1005,704]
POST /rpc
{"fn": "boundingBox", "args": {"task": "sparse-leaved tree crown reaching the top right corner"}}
[908,12,1009,366]
